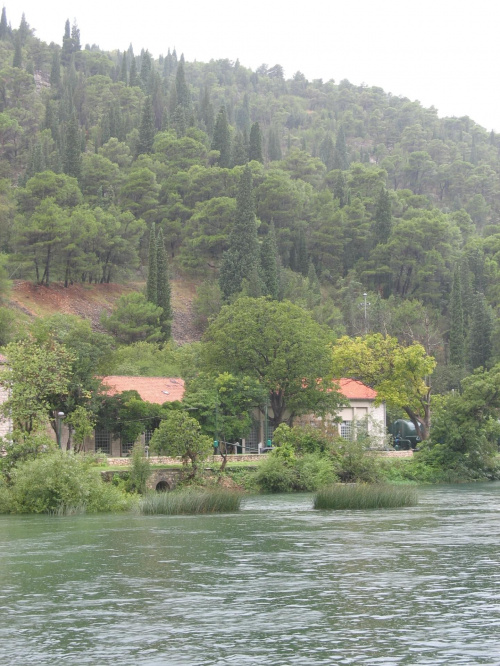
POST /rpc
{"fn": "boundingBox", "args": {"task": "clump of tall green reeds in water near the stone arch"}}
[139,489,241,516]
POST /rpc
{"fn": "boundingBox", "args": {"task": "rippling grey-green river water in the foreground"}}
[0,483,500,666]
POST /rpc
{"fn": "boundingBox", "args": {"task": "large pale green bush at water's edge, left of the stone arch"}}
[9,451,130,513]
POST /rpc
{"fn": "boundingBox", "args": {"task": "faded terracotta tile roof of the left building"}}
[102,375,184,405]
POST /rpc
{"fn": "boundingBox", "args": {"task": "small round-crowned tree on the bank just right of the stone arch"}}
[149,411,213,475]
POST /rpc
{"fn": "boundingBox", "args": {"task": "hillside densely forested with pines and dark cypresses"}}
[0,10,500,390]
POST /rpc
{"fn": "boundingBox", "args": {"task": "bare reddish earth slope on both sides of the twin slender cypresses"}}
[10,280,200,344]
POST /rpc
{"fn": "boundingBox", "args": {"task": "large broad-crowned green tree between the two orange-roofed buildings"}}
[203,297,343,426]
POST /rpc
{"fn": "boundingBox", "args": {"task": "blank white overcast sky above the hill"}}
[4,0,500,132]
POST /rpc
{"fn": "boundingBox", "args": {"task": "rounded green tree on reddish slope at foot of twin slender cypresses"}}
[101,293,162,344]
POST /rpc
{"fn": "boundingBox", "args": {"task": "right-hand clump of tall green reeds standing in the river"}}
[314,484,418,509]
